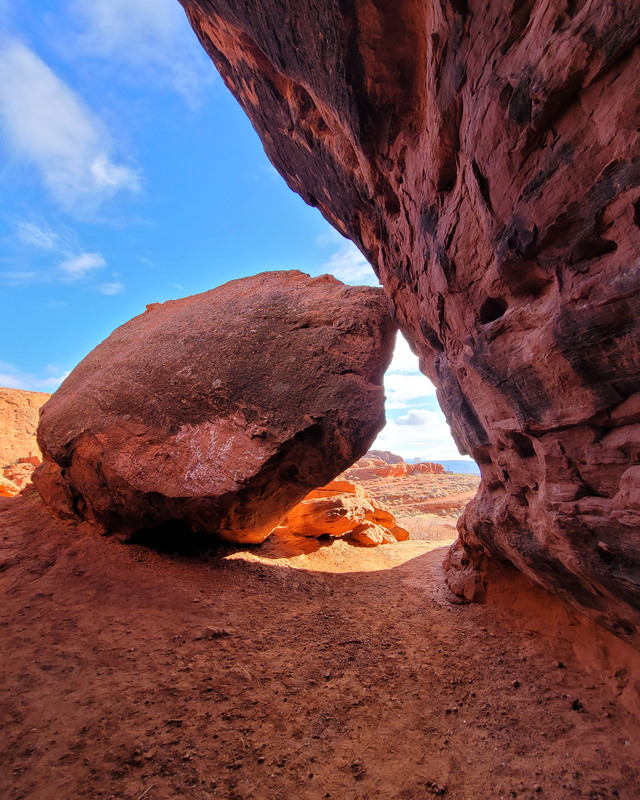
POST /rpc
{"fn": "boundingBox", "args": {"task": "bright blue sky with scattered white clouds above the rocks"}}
[0,0,470,459]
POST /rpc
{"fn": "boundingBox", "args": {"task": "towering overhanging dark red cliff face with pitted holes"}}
[181,0,640,642]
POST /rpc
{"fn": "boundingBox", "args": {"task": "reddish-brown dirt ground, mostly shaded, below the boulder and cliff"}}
[0,494,640,800]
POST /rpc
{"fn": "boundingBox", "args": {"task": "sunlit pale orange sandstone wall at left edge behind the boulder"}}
[0,388,51,468]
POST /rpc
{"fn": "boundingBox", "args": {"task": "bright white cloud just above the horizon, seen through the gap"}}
[372,408,462,461]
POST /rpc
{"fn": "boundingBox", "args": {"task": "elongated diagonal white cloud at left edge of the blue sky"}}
[0,38,139,210]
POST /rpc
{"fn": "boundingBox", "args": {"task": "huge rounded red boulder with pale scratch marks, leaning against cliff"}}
[33,271,395,542]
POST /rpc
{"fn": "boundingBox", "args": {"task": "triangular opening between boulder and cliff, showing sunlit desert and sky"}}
[225,333,480,573]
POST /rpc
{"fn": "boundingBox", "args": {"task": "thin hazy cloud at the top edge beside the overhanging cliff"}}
[71,0,216,104]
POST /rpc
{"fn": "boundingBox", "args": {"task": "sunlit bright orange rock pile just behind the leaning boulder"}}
[274,480,409,547]
